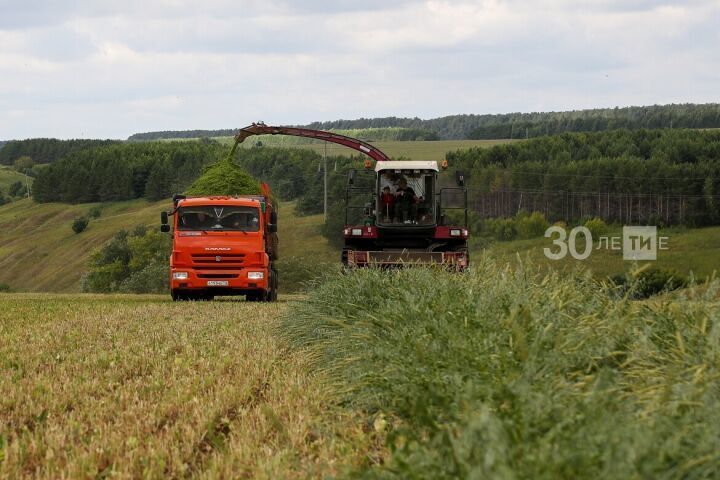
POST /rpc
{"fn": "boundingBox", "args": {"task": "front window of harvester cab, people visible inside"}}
[378,171,435,225]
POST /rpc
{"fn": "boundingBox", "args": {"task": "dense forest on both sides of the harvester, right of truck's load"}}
[239,129,720,232]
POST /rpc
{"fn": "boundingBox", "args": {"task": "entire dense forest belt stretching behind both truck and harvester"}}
[34,129,720,232]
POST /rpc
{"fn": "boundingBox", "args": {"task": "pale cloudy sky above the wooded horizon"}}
[0,0,720,140]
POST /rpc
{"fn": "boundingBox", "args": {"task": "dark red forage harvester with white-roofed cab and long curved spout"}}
[235,123,469,270]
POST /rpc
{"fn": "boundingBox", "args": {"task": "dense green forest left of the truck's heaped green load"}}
[33,142,228,203]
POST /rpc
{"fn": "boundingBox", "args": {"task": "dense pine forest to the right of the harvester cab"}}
[447,129,720,225]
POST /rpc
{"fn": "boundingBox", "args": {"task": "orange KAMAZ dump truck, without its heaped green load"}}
[160,185,278,302]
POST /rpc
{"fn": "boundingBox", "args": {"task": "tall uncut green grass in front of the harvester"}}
[283,260,720,479]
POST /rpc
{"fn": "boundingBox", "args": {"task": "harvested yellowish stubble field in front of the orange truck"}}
[0,294,380,479]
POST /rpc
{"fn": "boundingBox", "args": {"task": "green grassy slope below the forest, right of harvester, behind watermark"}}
[473,227,720,279]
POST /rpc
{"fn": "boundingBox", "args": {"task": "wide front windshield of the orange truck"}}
[178,205,260,232]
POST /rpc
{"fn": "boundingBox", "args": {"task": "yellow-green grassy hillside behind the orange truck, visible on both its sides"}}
[0,200,332,292]
